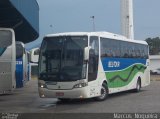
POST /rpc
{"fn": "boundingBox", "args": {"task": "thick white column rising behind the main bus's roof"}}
[121,0,134,39]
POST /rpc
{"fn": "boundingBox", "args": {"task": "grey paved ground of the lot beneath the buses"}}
[0,77,160,113]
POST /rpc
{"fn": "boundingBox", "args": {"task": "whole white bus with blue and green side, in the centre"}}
[38,32,150,100]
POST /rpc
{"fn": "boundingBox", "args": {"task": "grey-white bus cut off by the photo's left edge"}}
[0,28,16,94]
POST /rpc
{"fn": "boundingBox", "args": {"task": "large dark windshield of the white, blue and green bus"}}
[39,36,88,82]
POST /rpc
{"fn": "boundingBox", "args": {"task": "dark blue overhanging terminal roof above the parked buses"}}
[0,0,39,43]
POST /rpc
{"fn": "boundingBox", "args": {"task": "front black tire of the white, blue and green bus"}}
[95,83,108,101]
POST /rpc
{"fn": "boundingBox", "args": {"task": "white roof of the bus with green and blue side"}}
[45,31,147,45]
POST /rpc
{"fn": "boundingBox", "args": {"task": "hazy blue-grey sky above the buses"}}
[27,0,160,48]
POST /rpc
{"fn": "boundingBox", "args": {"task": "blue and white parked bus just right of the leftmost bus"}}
[16,41,29,88]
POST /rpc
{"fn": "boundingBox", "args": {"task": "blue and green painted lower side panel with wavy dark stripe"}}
[102,58,147,92]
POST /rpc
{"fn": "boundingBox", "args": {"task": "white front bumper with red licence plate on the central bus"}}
[38,87,90,99]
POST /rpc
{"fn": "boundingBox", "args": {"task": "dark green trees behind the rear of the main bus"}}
[146,37,160,55]
